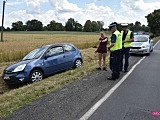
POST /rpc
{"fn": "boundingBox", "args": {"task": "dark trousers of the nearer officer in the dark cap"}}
[110,50,121,78]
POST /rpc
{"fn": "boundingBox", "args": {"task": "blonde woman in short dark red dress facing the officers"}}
[95,32,108,70]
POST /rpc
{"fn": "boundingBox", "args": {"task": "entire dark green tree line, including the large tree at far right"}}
[1,9,160,35]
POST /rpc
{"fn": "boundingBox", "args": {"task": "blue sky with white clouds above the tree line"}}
[0,0,160,28]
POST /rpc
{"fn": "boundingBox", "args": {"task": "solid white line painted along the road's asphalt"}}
[79,40,160,120]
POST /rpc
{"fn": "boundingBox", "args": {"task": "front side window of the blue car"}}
[47,46,64,56]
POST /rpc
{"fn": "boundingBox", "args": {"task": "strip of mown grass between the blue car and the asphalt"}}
[0,61,95,117]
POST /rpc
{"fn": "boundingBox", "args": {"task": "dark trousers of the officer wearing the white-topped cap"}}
[120,47,130,71]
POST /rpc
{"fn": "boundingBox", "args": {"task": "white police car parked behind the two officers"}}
[130,35,153,55]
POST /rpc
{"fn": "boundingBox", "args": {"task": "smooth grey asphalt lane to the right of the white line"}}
[84,42,160,120]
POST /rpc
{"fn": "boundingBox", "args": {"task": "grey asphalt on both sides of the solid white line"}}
[4,40,160,120]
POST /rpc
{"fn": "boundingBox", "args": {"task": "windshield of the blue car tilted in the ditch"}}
[23,47,45,60]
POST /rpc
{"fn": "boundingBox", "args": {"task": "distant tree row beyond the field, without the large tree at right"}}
[2,18,149,32]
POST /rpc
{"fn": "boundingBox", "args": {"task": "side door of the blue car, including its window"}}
[44,46,66,74]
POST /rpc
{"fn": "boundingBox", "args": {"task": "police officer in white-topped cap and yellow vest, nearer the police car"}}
[120,24,134,72]
